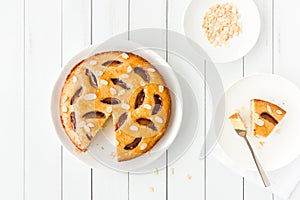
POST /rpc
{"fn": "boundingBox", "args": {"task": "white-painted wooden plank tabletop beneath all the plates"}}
[0,0,300,200]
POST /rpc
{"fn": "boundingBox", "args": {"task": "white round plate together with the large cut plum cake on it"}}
[51,40,182,172]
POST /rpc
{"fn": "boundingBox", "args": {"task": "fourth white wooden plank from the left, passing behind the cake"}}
[92,0,128,200]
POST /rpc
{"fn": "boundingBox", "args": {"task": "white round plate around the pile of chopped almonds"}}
[184,0,260,63]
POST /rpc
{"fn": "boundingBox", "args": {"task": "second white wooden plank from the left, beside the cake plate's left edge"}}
[25,0,61,200]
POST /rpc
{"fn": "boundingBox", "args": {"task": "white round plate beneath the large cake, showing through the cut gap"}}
[51,40,182,172]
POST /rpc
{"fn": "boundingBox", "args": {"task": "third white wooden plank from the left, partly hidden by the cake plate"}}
[61,0,91,200]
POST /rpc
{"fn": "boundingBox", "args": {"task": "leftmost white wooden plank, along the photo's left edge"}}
[0,0,24,199]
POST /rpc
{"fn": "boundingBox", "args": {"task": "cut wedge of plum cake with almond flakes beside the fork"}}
[250,99,286,138]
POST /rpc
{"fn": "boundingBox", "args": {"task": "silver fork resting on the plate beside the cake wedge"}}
[233,116,270,187]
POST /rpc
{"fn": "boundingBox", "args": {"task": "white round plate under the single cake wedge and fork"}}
[216,74,300,170]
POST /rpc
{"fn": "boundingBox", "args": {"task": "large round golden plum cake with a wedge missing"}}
[60,51,171,161]
